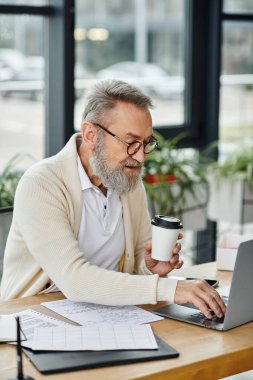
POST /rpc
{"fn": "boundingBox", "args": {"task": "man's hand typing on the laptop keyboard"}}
[174,280,226,319]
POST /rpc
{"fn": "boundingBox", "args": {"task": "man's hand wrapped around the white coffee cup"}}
[145,233,183,276]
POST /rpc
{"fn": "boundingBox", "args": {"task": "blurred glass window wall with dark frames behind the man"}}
[0,0,253,263]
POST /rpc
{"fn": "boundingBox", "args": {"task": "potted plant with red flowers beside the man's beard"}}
[143,131,207,230]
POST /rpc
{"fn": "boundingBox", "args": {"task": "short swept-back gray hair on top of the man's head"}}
[82,80,153,121]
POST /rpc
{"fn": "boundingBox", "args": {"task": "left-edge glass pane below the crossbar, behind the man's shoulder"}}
[0,15,45,167]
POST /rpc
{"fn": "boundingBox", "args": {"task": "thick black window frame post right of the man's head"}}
[154,0,221,149]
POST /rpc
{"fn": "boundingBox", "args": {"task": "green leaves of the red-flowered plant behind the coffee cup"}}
[144,131,207,217]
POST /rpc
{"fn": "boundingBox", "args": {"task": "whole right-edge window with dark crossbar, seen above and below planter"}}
[217,0,253,240]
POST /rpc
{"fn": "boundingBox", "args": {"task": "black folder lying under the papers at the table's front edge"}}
[23,337,179,374]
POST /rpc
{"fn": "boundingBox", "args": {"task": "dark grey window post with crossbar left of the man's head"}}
[0,0,75,157]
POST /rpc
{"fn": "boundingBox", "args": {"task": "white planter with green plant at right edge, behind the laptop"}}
[208,143,253,224]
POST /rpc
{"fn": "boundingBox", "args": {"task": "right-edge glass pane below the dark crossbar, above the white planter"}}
[219,19,253,148]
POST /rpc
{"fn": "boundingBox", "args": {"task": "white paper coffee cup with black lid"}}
[151,215,183,261]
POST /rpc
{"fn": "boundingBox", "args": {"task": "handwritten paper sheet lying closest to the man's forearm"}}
[42,299,163,326]
